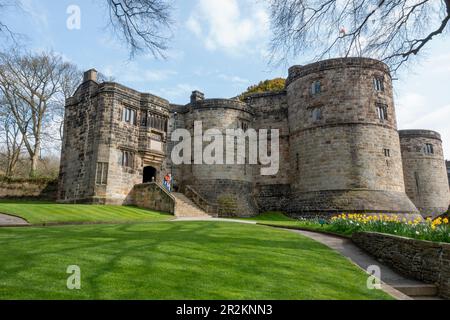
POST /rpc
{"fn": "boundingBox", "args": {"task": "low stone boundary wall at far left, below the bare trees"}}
[0,180,58,201]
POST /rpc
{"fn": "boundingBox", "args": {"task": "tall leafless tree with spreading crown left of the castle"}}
[0,50,76,177]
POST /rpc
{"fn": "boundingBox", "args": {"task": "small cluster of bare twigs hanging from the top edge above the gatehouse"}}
[107,0,172,58]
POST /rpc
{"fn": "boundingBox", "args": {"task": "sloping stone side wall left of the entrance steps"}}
[125,183,175,214]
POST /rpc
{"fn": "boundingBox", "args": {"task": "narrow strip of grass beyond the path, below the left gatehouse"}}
[0,201,173,225]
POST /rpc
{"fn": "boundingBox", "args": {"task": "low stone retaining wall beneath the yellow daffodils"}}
[352,232,450,299]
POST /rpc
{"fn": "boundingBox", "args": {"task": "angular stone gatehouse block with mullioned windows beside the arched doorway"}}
[58,70,169,204]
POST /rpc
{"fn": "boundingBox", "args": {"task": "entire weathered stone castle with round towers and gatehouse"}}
[58,58,450,216]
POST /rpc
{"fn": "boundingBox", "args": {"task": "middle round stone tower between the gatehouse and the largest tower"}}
[178,92,258,216]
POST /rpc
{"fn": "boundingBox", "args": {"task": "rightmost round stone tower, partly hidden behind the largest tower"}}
[399,130,450,217]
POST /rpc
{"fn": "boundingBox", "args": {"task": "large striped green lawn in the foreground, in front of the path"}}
[0,222,390,299]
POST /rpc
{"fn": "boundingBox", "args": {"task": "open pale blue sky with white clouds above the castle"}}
[2,0,450,159]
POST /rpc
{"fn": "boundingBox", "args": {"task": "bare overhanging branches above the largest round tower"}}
[269,0,450,71]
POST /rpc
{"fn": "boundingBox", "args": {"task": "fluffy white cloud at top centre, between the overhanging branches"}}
[186,0,269,55]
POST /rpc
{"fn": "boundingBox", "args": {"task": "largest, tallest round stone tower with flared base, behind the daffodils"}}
[286,58,418,215]
